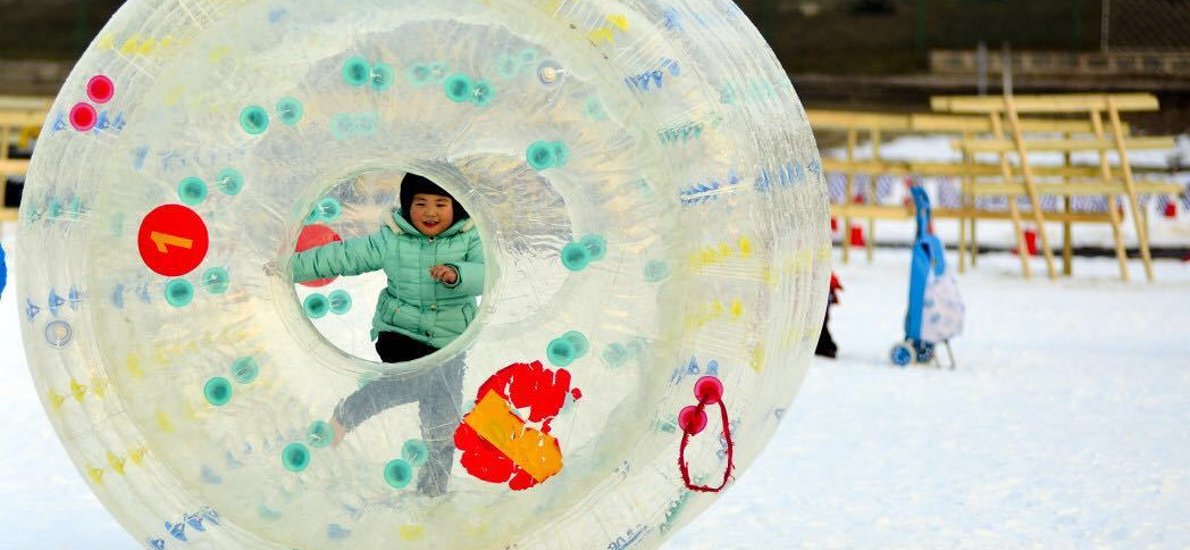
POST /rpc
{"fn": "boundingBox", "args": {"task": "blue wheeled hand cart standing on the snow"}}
[889,186,954,369]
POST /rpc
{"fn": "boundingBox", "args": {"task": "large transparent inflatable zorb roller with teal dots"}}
[17,0,829,550]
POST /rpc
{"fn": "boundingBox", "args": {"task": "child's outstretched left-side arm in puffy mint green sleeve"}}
[292,227,393,282]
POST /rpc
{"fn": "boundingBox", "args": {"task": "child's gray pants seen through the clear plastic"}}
[334,347,463,496]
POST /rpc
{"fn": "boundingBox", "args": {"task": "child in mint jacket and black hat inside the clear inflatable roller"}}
[292,174,484,496]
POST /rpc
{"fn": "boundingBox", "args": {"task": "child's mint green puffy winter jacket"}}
[293,210,484,348]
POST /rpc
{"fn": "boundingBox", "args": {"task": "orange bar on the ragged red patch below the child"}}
[464,392,562,483]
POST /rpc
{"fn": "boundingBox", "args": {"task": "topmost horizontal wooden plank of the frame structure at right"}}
[929,93,1160,114]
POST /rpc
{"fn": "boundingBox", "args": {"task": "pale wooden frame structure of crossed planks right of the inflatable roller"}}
[808,94,1182,280]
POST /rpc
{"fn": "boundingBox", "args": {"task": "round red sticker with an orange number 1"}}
[137,205,211,277]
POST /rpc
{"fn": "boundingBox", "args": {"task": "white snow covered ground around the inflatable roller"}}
[0,234,1190,550]
